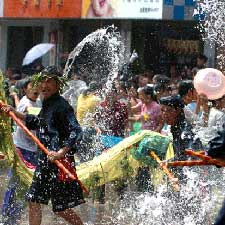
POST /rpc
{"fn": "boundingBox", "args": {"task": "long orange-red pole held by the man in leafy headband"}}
[0,100,89,194]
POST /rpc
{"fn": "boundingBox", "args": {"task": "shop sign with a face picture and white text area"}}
[82,0,163,19]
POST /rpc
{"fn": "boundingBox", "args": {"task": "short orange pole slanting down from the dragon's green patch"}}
[150,151,180,191]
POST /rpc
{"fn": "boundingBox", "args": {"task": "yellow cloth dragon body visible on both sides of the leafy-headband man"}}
[0,73,174,192]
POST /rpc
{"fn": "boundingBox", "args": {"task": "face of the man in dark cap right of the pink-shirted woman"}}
[161,105,180,125]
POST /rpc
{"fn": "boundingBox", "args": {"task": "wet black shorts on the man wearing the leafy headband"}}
[26,163,84,212]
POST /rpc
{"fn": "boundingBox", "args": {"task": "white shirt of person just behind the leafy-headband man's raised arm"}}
[13,96,41,152]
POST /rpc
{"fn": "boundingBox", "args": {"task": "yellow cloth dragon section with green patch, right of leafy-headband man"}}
[76,130,174,188]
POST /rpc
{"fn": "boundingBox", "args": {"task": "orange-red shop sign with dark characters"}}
[3,0,82,18]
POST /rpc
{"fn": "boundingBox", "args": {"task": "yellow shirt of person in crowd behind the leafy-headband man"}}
[77,94,99,127]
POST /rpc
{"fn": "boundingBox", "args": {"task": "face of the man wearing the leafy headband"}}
[40,78,59,99]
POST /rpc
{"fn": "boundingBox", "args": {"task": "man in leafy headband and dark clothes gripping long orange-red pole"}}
[1,66,84,225]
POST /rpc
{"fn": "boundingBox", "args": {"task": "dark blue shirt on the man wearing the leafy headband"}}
[26,94,82,163]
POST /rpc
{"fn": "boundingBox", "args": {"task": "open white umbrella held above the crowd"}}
[22,43,55,66]
